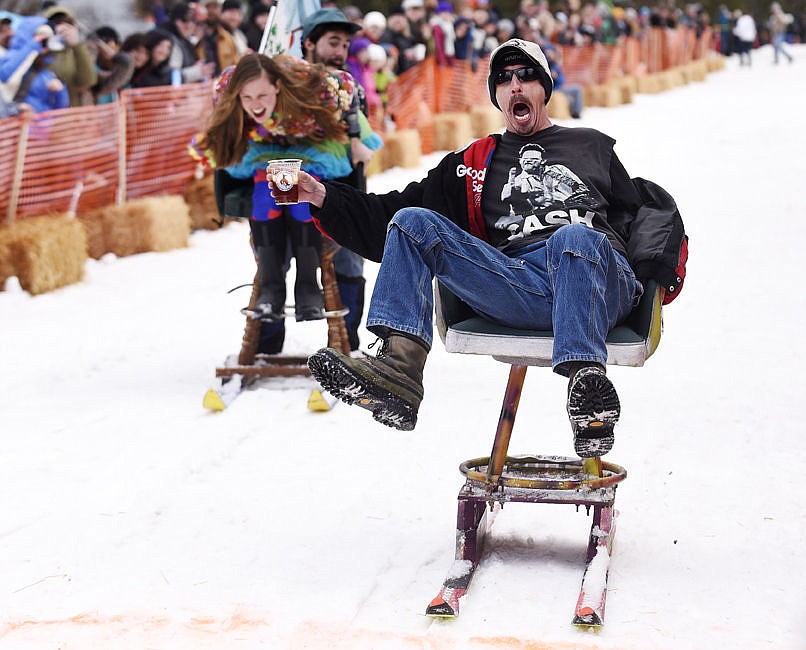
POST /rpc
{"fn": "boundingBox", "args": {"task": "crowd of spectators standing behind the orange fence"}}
[0,0,804,117]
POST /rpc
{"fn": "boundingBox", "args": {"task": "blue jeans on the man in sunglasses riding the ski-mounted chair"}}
[367,208,642,370]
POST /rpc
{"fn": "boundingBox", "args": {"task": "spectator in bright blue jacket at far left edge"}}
[0,16,70,113]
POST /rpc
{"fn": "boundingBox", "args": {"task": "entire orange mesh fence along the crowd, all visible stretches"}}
[0,28,712,222]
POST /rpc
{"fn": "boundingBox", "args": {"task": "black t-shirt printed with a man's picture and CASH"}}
[481,125,634,253]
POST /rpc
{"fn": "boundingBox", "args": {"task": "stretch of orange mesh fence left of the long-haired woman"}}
[0,84,211,222]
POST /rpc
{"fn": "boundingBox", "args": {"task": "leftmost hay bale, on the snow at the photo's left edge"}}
[3,215,87,295]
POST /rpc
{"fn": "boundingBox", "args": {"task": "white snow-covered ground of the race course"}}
[0,47,806,650]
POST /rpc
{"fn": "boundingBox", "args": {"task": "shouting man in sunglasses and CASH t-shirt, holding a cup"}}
[292,39,686,457]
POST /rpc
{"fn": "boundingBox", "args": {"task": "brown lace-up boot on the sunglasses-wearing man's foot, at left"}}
[308,332,429,431]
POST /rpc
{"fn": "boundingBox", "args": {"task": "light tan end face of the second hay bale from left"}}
[120,195,190,252]
